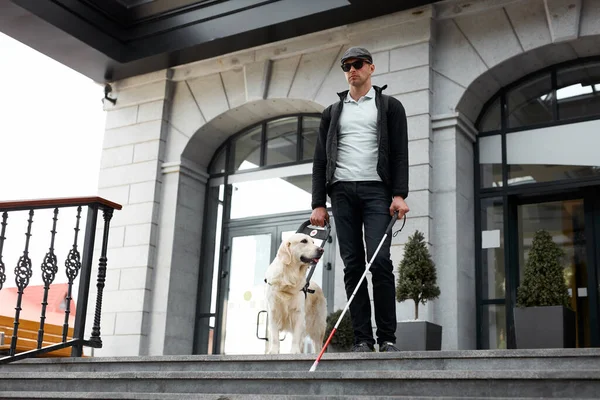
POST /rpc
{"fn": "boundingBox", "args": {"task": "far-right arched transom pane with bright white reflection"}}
[556,63,600,119]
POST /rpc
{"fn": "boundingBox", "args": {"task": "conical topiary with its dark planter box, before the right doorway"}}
[514,229,575,349]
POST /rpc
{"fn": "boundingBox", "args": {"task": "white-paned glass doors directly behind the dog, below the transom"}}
[214,213,336,354]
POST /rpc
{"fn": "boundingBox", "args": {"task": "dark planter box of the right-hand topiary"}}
[514,306,576,349]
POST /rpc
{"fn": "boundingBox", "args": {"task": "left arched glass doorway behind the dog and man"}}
[194,113,336,354]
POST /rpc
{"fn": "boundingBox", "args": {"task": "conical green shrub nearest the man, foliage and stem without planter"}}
[396,231,440,319]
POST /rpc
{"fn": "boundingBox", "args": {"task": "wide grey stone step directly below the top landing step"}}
[0,368,600,399]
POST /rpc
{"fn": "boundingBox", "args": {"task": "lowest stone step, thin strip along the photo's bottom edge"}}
[0,392,595,400]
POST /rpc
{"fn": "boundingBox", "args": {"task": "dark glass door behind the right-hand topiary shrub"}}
[515,191,600,347]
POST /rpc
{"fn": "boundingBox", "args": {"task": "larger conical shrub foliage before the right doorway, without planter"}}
[517,229,571,309]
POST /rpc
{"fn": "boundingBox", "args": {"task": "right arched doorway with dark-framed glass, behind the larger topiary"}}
[475,57,600,349]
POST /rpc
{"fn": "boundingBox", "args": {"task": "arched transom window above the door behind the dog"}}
[209,114,321,220]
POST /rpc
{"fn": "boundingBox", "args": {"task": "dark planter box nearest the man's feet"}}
[396,321,442,351]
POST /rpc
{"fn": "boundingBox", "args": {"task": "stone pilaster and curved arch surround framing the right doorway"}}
[431,0,600,349]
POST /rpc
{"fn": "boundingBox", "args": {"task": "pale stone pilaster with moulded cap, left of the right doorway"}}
[432,113,476,350]
